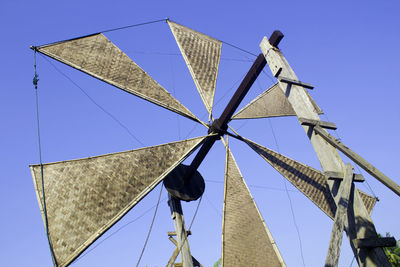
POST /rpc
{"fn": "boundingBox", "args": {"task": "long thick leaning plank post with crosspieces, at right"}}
[260,37,391,267]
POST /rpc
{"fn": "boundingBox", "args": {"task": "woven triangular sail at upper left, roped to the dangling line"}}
[37,33,198,121]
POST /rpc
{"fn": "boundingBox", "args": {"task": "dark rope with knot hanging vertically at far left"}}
[33,50,58,266]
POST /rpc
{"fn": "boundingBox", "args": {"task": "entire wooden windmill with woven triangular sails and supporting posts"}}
[31,20,400,266]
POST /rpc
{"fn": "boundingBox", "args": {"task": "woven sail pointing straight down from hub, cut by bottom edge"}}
[222,147,286,267]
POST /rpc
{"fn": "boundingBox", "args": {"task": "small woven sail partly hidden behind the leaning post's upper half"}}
[232,83,322,119]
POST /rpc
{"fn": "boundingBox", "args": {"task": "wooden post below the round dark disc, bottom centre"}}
[167,194,193,267]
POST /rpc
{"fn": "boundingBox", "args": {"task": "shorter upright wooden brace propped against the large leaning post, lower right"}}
[325,164,354,267]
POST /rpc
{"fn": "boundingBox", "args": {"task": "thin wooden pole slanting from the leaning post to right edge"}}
[314,126,400,196]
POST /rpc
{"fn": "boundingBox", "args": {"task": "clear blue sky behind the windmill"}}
[0,0,400,266]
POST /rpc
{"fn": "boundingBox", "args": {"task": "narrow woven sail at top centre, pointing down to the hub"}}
[168,20,222,114]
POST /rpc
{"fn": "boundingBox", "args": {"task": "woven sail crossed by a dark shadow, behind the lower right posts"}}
[243,138,376,219]
